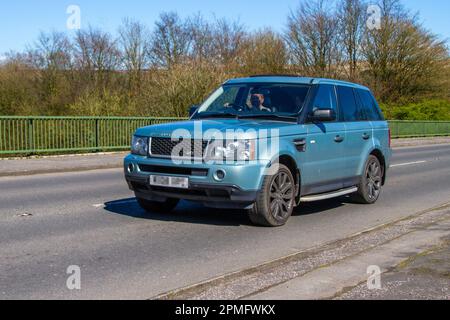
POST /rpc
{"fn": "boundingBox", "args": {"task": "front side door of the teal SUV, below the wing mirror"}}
[302,84,346,194]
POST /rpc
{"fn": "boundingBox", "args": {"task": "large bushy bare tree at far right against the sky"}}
[363,0,448,101]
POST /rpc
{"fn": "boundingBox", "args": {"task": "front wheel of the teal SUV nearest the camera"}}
[248,164,296,227]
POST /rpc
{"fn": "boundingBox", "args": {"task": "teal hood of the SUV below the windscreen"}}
[136,119,306,139]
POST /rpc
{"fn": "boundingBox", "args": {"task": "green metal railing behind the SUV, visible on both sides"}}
[0,116,450,155]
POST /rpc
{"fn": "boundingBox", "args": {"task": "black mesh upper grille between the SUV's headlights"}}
[150,137,208,158]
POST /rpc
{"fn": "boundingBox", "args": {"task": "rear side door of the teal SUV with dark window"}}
[337,86,372,182]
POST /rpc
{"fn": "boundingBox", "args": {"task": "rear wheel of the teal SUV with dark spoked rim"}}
[353,155,384,204]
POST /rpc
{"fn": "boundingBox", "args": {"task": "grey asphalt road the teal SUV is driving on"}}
[0,145,450,299]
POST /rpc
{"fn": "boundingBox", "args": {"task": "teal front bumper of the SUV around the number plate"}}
[124,155,270,208]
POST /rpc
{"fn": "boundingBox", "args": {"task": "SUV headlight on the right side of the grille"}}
[210,140,255,161]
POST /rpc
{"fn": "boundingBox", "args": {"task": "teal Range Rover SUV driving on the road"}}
[124,76,391,226]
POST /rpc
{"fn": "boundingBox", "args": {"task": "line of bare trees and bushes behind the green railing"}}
[0,0,450,119]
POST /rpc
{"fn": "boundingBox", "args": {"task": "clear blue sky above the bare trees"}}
[0,0,450,53]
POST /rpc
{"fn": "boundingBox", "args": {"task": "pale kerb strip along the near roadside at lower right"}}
[151,202,450,300]
